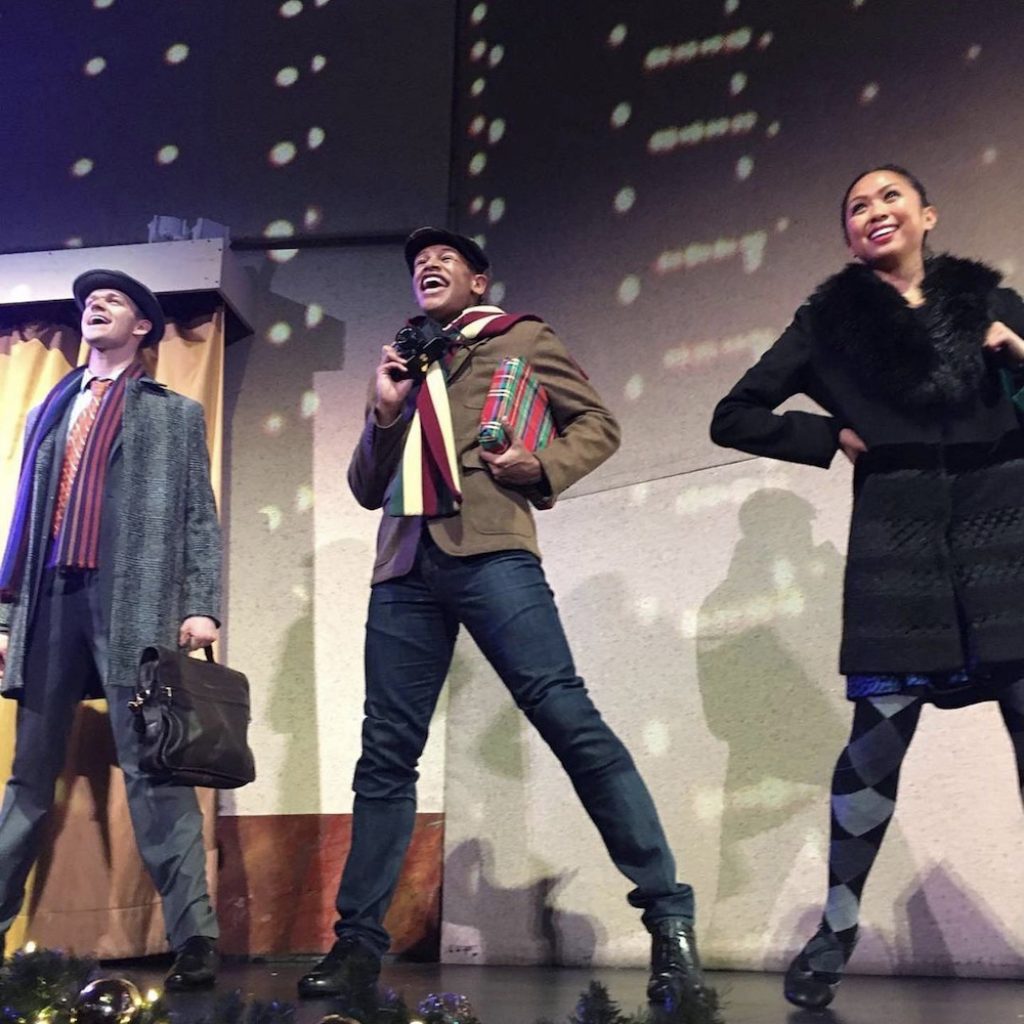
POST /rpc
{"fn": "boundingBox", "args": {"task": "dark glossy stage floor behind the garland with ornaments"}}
[104,961,1024,1024]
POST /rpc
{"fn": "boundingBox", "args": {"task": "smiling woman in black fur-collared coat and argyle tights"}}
[711,164,1024,1009]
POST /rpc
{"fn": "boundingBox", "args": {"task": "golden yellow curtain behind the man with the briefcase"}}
[0,303,224,957]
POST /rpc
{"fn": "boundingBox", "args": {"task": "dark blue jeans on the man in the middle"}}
[335,534,693,954]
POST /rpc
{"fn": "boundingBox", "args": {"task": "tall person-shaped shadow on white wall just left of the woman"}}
[697,488,912,968]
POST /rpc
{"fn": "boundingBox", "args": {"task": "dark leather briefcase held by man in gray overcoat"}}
[128,646,256,790]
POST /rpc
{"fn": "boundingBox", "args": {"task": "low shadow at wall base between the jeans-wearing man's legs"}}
[444,839,604,965]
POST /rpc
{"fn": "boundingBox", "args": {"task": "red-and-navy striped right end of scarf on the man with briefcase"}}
[52,362,145,569]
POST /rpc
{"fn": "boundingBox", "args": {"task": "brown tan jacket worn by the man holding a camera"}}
[348,321,620,583]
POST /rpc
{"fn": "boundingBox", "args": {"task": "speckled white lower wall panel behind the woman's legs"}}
[442,460,1024,975]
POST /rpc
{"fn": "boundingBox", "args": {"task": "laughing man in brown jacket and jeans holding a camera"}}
[299,227,707,1016]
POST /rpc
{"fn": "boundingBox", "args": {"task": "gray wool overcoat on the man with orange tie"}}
[0,377,221,699]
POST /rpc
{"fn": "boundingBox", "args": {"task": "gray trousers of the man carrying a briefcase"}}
[0,570,218,948]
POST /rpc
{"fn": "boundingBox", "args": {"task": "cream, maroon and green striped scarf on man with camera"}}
[387,306,540,516]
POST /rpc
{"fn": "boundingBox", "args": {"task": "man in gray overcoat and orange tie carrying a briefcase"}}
[0,269,221,989]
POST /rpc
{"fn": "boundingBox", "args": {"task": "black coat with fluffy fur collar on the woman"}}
[711,256,1024,674]
